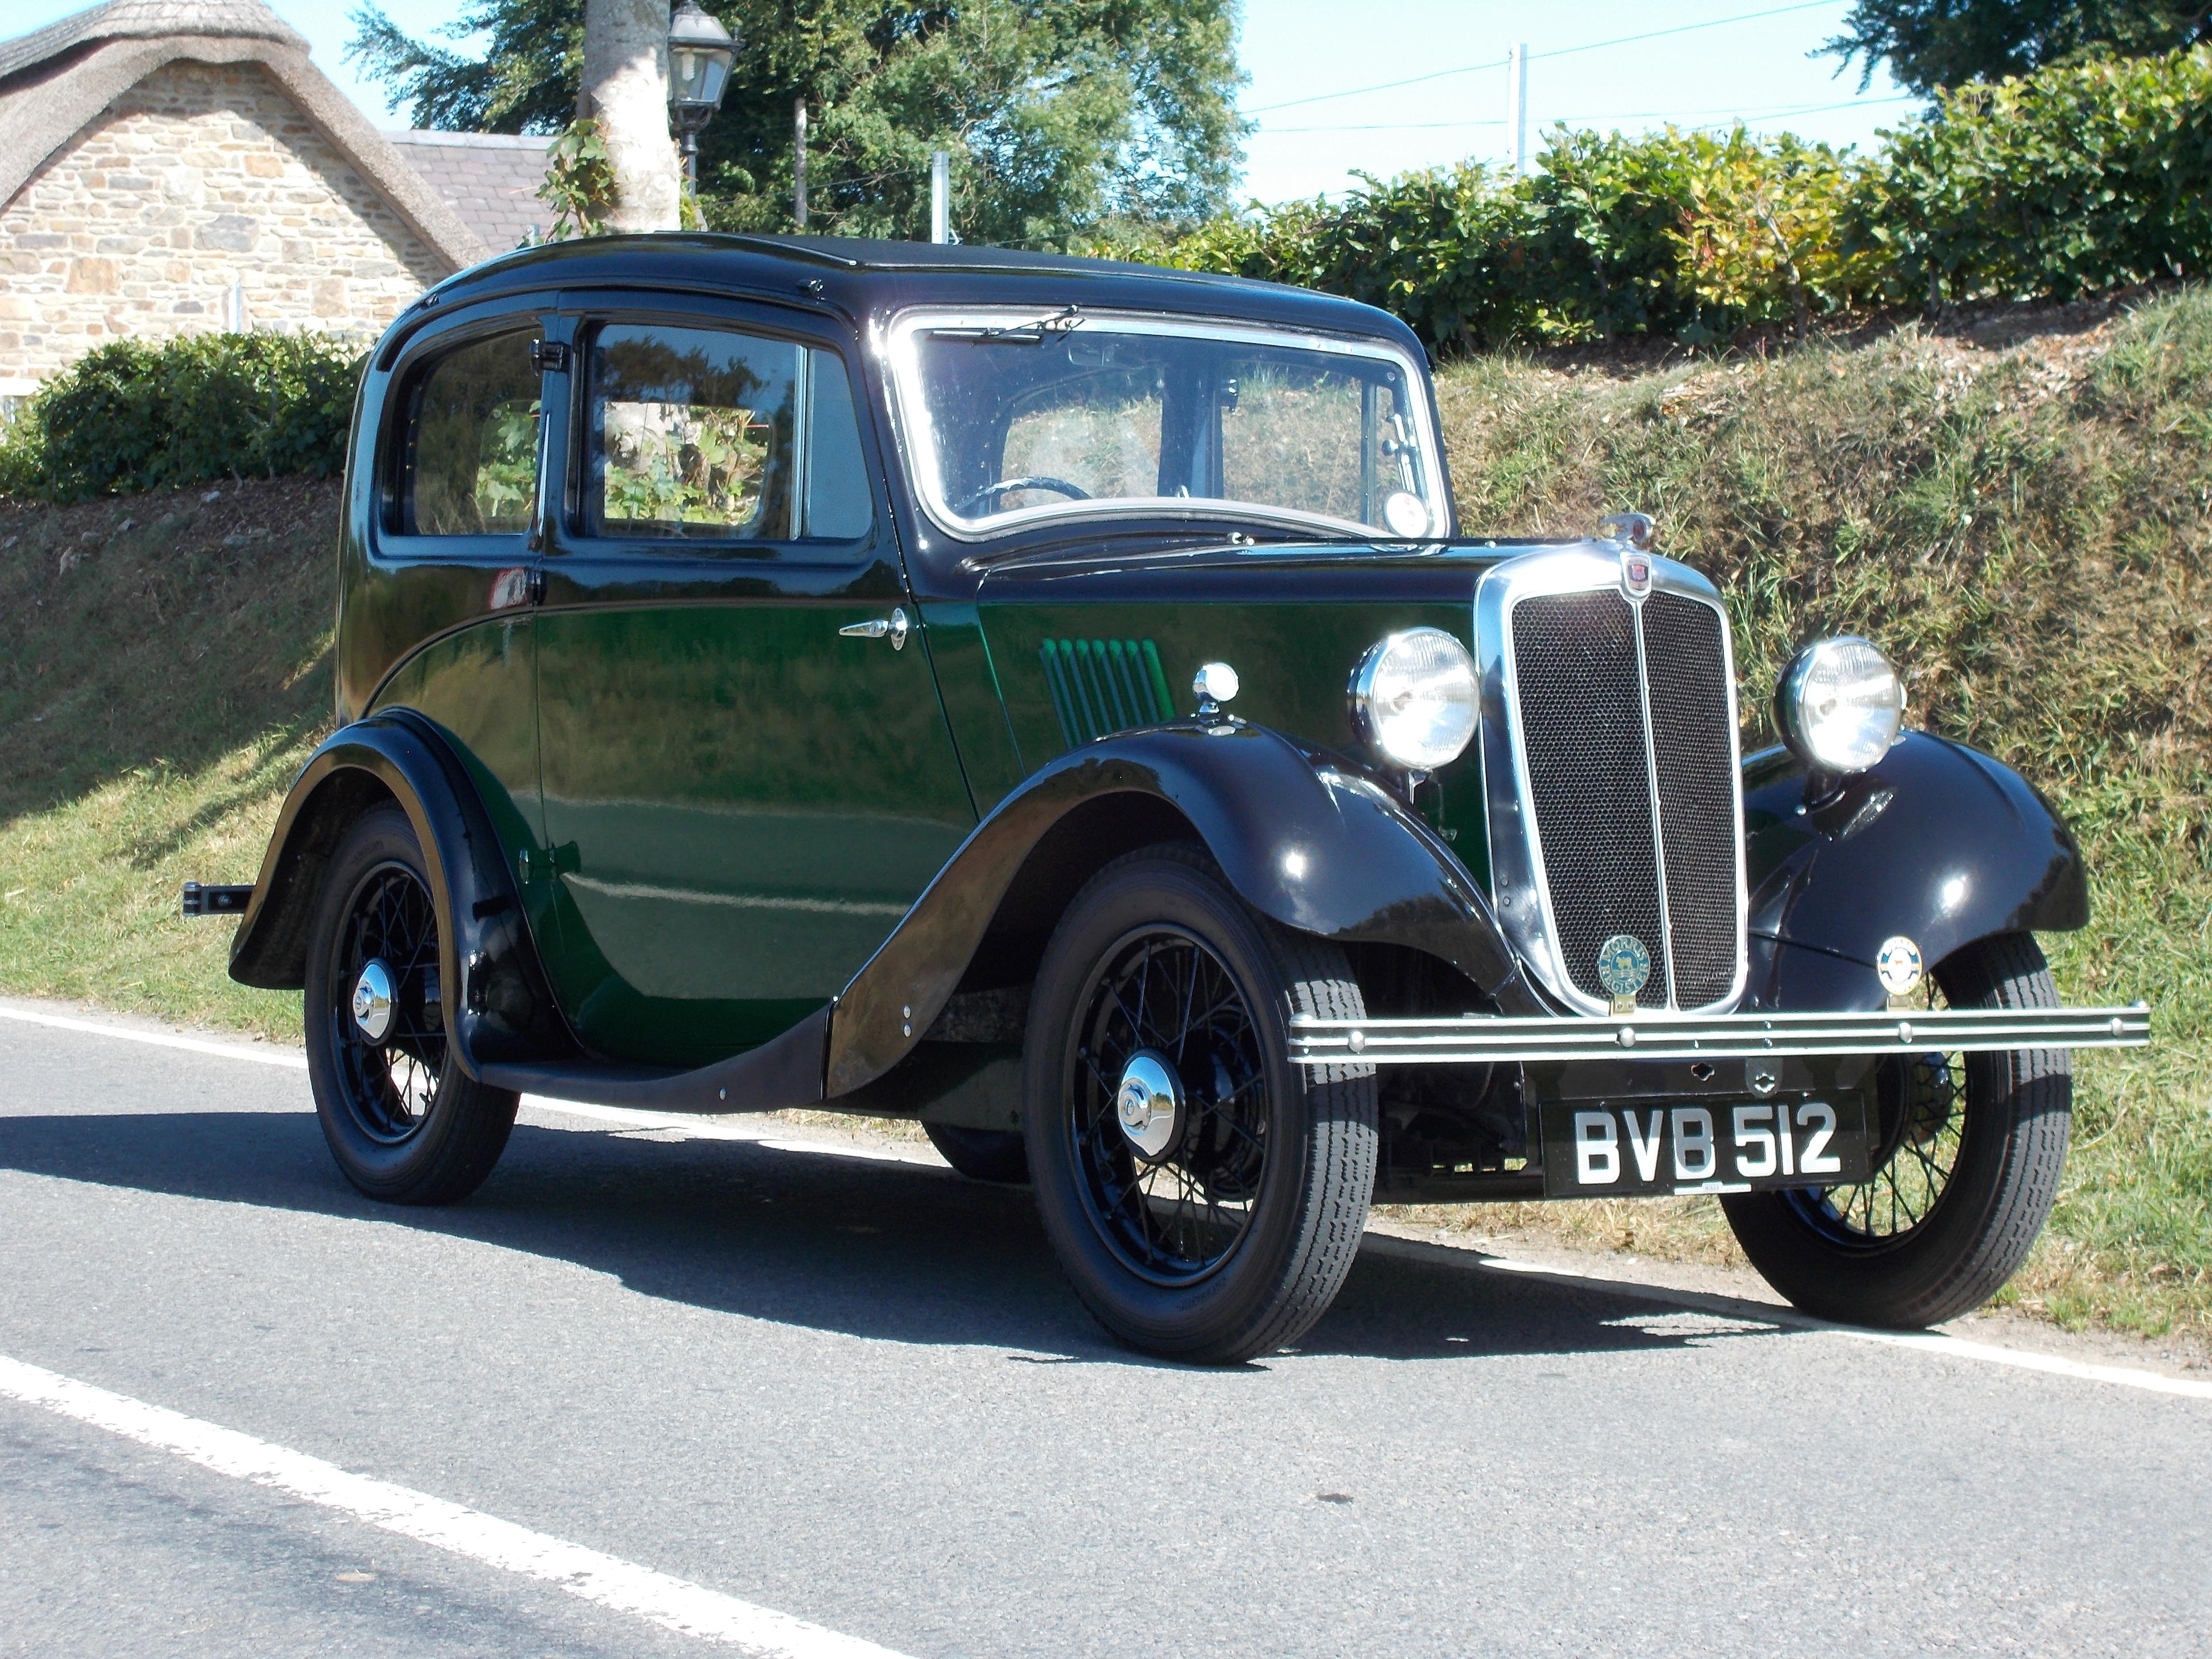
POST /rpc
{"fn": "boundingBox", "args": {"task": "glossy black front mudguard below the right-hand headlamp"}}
[1743,732,2088,1011]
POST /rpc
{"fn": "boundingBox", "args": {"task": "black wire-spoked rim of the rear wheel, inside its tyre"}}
[325,863,445,1146]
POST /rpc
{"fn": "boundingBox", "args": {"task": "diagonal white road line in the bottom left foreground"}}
[0,1356,900,1659]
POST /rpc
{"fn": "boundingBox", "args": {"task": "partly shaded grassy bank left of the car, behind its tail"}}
[0,480,339,1037]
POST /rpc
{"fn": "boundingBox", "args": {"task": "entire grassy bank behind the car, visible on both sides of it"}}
[0,294,2212,1334]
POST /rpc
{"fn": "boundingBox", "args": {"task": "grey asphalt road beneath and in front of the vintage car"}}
[0,1020,2212,1659]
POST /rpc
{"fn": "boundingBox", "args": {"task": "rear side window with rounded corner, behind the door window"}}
[394,329,537,535]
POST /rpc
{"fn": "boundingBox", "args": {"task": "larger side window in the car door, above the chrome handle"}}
[584,323,874,553]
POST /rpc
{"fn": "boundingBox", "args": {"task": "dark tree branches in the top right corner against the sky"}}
[1820,0,2212,95]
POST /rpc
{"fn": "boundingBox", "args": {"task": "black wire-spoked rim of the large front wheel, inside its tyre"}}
[1069,927,1272,1285]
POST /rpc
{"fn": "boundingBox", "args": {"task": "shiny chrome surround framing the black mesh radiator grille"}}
[1475,542,1749,1017]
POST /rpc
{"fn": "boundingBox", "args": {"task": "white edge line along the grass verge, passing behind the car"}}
[0,1006,2212,1400]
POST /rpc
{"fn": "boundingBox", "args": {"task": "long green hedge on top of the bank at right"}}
[1090,48,2212,350]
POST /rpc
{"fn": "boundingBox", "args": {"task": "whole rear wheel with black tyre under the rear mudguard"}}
[305,805,518,1203]
